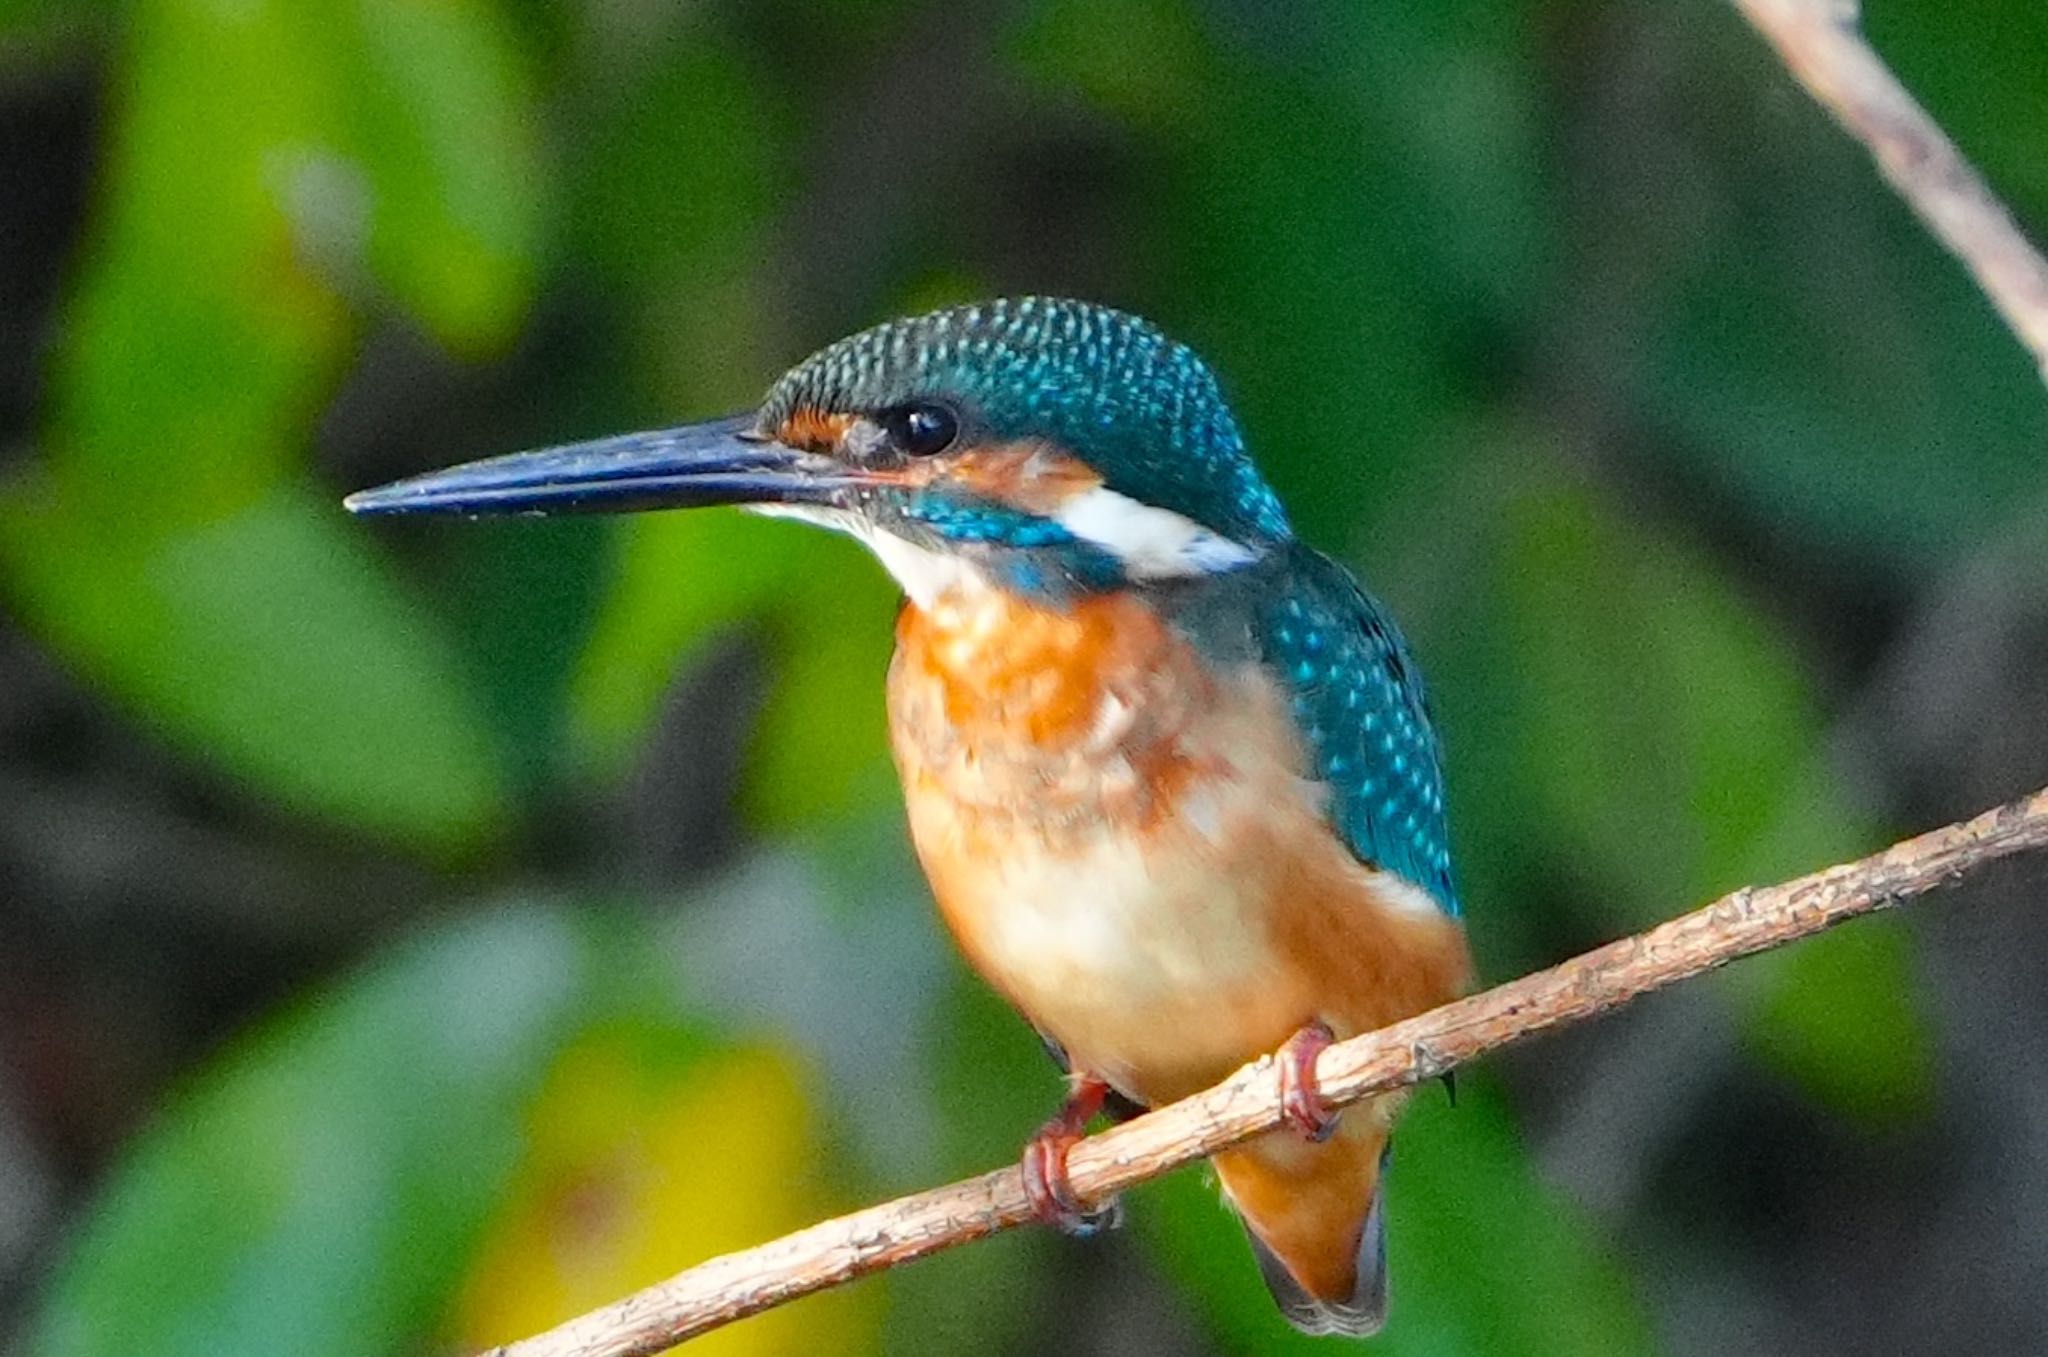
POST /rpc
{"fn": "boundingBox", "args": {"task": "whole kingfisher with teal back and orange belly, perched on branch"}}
[346,297,1470,1337]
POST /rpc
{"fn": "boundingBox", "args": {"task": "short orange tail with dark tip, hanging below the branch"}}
[1214,1103,1386,1339]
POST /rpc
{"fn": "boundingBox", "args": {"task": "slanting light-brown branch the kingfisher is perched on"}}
[487,788,2048,1357]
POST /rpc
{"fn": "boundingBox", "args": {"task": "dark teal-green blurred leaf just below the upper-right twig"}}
[1647,236,2048,575]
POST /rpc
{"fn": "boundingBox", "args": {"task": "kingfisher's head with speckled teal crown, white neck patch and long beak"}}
[348,297,1290,602]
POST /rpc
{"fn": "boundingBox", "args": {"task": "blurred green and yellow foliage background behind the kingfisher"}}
[0,0,2048,1357]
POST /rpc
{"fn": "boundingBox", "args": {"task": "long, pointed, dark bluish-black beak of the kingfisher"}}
[342,415,858,514]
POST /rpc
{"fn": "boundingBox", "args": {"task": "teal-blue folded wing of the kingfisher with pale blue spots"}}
[1257,546,1458,915]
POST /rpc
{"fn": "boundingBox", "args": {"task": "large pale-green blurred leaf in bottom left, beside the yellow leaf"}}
[29,909,608,1357]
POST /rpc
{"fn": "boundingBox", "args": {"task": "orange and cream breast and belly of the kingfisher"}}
[889,589,1466,1101]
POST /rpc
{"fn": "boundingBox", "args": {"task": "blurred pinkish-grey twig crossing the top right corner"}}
[1735,0,2048,381]
